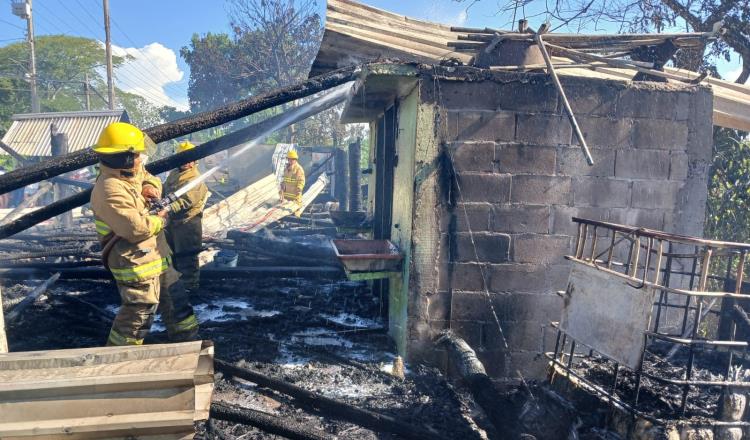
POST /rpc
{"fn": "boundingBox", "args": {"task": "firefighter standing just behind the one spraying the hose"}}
[164,142,208,291]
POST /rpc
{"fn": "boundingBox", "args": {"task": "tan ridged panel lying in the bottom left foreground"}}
[0,341,213,440]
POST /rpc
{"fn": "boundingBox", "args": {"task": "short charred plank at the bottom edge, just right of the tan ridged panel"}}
[209,402,331,440]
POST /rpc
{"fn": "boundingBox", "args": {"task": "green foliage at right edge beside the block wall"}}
[704,128,750,243]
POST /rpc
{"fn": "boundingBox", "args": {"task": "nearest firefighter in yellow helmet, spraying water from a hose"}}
[91,122,198,345]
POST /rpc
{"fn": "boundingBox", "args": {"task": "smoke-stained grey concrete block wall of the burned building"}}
[409,70,712,377]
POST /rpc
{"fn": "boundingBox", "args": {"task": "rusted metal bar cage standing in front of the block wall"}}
[547,218,750,426]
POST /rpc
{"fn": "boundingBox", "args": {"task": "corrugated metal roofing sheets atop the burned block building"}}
[310,0,750,131]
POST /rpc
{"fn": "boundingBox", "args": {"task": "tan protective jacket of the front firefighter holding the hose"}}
[91,164,170,283]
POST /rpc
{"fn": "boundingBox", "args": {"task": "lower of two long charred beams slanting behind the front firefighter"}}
[0,89,352,239]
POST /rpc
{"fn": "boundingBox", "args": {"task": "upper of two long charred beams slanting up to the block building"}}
[0,66,359,194]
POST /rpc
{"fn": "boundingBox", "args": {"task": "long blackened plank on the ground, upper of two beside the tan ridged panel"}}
[214,359,445,440]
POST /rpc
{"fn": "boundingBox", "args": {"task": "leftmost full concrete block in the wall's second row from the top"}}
[448,111,516,142]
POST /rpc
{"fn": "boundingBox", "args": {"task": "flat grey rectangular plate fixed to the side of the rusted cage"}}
[560,262,656,370]
